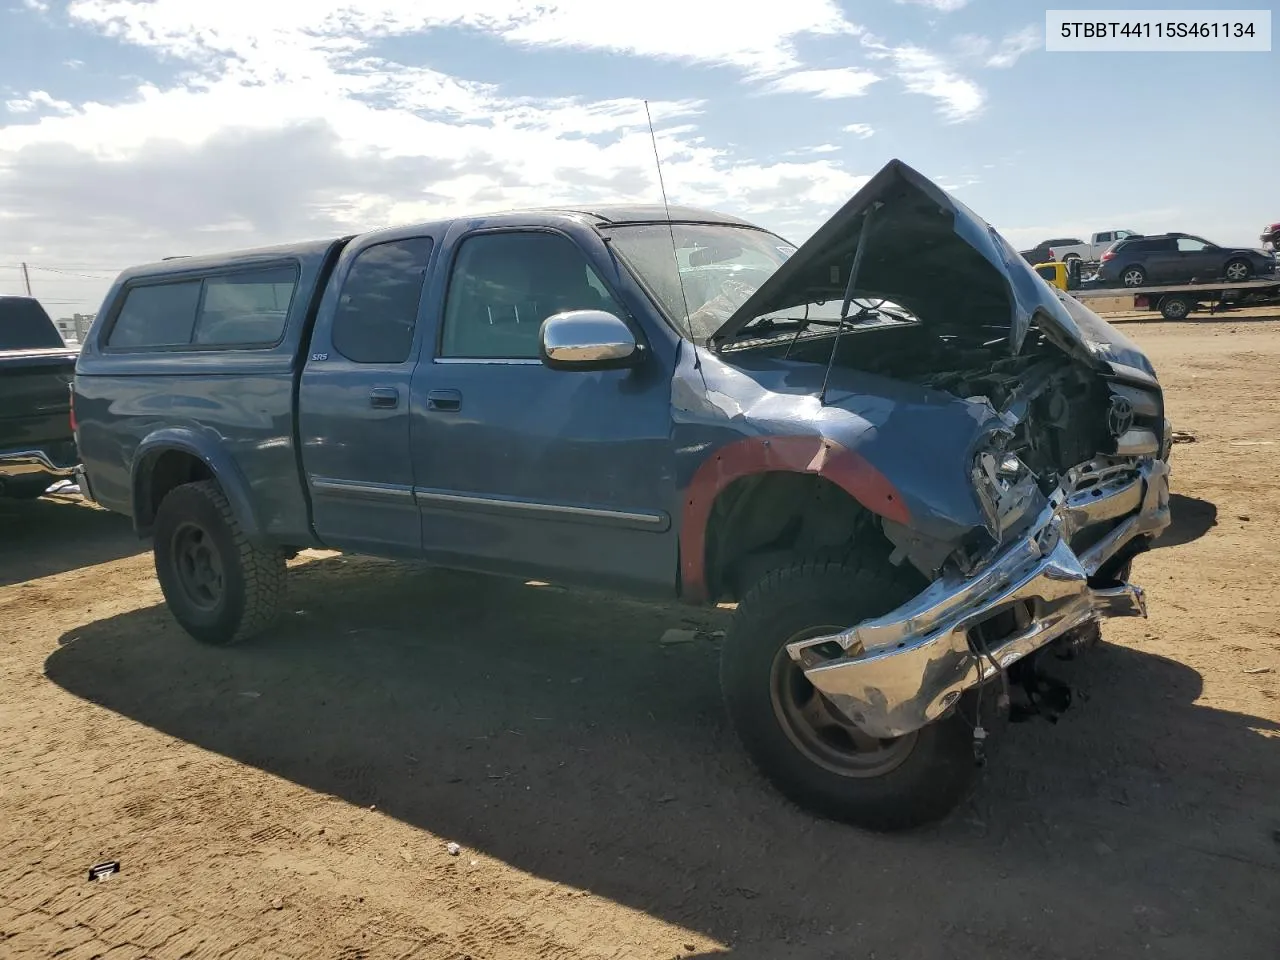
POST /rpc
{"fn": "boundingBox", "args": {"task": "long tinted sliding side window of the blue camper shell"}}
[106,264,298,349]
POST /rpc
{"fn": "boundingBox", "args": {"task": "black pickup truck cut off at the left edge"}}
[0,297,79,499]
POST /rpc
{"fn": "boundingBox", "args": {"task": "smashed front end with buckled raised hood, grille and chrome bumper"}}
[712,161,1170,739]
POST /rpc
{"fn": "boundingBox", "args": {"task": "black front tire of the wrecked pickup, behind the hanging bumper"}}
[721,558,975,831]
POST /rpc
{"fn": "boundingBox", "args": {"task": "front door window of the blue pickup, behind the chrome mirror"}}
[440,233,625,360]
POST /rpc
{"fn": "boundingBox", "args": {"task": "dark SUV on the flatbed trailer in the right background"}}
[1097,233,1276,287]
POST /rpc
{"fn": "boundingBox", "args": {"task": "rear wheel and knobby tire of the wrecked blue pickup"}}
[154,480,285,646]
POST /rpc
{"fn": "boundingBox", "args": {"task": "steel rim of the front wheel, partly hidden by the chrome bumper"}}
[769,626,918,778]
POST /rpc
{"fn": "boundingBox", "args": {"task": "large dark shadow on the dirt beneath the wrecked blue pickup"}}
[46,557,1280,959]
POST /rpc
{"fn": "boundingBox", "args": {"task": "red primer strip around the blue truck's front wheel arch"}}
[680,436,910,600]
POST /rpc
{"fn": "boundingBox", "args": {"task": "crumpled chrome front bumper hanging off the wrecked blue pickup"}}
[787,460,1169,737]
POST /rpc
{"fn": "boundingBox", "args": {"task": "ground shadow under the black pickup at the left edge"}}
[0,494,141,586]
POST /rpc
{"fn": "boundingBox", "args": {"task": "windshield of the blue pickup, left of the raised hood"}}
[602,223,796,343]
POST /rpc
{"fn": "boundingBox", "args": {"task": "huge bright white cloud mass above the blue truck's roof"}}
[0,0,921,308]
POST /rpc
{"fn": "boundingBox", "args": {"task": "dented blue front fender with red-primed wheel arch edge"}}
[672,344,1001,599]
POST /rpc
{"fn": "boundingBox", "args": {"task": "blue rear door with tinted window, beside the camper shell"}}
[298,236,435,556]
